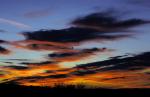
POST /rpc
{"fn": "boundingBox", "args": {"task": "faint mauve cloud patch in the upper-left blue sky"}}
[24,8,50,18]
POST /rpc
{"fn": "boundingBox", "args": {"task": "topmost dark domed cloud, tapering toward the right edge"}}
[72,11,150,32]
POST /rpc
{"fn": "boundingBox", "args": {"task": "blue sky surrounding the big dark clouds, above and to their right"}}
[0,0,150,65]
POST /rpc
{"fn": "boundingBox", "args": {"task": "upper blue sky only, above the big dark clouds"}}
[0,0,149,33]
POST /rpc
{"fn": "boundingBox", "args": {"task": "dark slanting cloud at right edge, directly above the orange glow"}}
[76,52,150,74]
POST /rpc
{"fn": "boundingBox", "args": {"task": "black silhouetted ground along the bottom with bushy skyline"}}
[0,84,150,97]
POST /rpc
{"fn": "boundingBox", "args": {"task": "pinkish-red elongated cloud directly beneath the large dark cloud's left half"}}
[11,40,78,52]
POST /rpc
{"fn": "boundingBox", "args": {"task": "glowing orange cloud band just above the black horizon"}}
[14,71,150,88]
